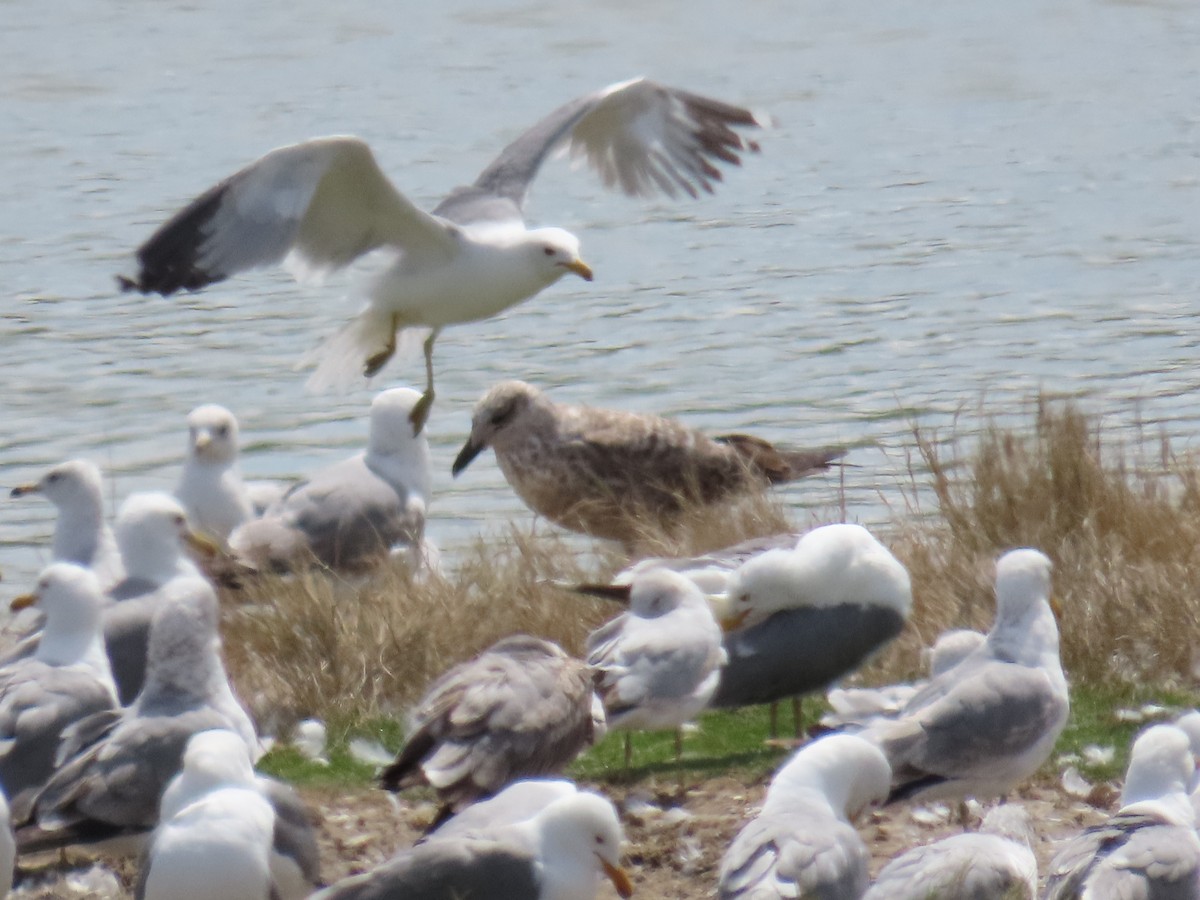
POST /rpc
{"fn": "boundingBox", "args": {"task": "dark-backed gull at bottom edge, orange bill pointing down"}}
[313,791,634,900]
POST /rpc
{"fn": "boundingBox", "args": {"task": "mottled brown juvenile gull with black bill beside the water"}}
[452,382,844,542]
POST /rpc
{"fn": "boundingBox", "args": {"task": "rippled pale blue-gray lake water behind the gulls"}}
[0,0,1200,596]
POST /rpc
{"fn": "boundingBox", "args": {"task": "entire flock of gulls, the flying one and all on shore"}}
[0,79,1200,900]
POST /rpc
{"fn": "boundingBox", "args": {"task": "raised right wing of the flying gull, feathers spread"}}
[434,78,762,223]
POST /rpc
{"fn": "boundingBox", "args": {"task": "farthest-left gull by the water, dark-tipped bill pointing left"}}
[11,460,124,590]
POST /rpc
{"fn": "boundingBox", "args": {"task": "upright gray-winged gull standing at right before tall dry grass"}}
[863,550,1069,802]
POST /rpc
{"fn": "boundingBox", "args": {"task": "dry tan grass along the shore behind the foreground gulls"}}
[224,402,1200,727]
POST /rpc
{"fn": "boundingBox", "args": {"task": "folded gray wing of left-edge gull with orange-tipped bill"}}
[0,660,114,822]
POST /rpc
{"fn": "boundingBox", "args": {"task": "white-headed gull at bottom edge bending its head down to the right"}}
[718,734,890,900]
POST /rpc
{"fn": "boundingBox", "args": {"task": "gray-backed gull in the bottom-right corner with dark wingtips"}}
[1045,725,1200,900]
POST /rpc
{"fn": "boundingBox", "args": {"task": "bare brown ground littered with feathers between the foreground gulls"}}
[17,776,1116,900]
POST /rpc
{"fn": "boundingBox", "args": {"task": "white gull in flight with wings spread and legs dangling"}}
[119,78,763,431]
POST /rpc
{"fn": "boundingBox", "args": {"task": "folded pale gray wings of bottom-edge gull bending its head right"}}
[718,811,870,900]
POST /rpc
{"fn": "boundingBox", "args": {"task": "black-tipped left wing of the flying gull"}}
[119,137,455,296]
